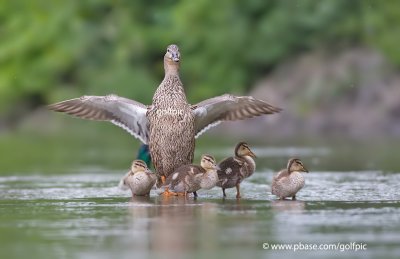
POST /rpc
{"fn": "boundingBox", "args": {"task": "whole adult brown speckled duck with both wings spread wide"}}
[49,45,281,185]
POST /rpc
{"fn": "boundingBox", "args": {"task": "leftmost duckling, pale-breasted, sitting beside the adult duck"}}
[118,159,157,196]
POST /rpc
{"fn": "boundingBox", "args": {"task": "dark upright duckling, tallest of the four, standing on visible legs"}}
[217,142,256,198]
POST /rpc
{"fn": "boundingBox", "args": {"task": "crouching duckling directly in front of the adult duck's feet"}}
[165,154,218,197]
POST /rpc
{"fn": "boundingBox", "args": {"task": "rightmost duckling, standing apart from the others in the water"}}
[271,158,308,200]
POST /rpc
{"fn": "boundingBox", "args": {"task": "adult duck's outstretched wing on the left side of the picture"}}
[48,95,148,144]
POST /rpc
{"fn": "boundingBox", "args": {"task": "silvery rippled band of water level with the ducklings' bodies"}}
[0,171,400,201]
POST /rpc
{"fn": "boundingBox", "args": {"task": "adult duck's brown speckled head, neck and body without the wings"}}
[147,45,196,186]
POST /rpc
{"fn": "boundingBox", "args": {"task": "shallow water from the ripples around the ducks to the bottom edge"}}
[0,169,400,258]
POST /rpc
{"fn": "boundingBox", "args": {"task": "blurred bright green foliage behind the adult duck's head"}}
[0,0,400,120]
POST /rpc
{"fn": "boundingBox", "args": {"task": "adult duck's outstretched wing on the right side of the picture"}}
[192,94,281,138]
